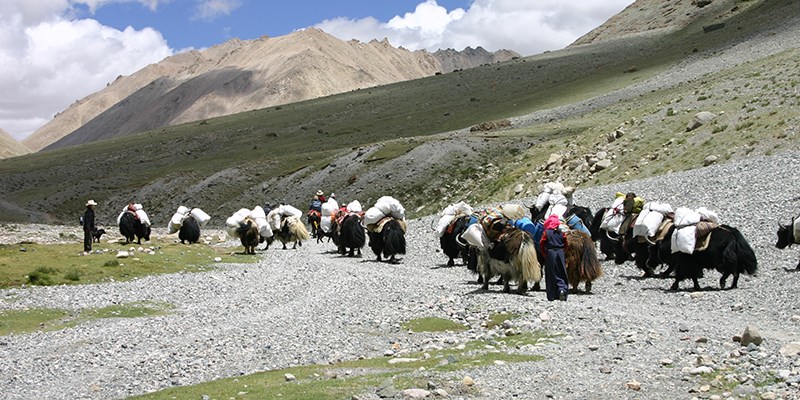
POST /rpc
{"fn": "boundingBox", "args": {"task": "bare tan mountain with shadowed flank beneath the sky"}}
[25,29,519,150]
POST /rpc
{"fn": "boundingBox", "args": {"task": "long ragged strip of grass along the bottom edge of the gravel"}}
[133,332,550,400]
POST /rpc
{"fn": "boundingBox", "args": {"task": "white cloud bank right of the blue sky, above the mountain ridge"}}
[315,0,633,55]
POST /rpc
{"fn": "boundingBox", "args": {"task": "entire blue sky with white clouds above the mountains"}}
[0,0,633,140]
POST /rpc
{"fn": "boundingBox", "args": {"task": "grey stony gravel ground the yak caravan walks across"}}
[0,152,800,399]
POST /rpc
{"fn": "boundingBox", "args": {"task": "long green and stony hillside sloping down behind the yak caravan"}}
[0,0,800,227]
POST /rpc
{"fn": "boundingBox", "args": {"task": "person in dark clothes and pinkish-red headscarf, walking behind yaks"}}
[540,214,569,301]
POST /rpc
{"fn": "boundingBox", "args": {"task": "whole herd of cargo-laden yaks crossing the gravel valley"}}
[112,186,800,294]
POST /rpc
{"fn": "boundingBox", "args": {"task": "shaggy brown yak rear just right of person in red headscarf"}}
[564,230,603,293]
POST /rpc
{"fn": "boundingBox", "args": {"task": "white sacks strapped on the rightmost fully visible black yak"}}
[671,207,719,254]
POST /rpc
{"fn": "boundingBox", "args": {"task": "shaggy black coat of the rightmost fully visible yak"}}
[658,225,758,291]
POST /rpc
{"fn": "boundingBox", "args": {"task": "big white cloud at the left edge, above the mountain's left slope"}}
[0,0,173,139]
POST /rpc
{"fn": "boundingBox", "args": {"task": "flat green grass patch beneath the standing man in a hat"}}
[0,240,258,288]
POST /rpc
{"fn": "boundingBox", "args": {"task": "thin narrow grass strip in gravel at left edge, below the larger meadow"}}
[0,302,173,336]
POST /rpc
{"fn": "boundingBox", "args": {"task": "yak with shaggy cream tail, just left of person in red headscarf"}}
[478,228,542,294]
